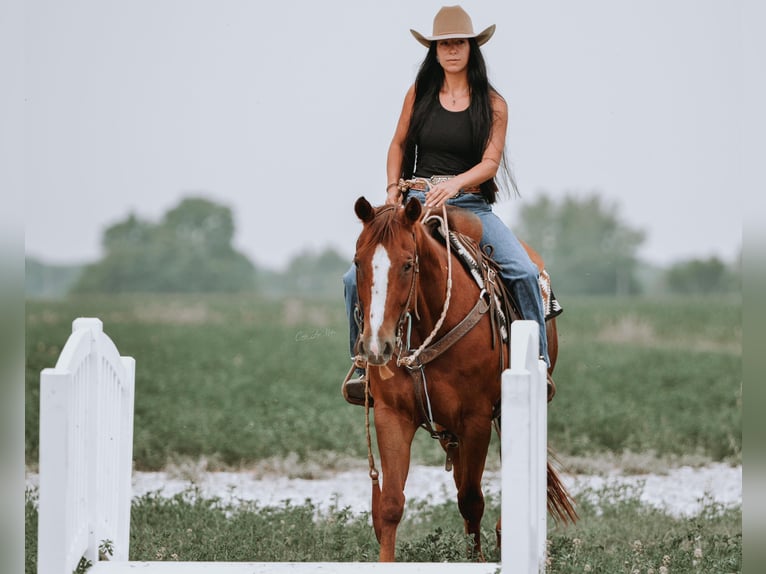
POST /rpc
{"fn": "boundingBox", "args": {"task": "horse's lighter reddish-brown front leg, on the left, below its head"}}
[372,404,417,562]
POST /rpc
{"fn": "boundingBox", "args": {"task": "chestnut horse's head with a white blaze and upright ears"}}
[354,197,422,365]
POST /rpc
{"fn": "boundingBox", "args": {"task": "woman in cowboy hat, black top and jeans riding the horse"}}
[343,6,554,404]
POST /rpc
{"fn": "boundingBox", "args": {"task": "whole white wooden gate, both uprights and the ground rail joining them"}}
[37,318,547,574]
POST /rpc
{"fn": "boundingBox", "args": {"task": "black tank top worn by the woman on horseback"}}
[415,102,477,177]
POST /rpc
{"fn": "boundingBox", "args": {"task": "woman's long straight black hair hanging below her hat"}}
[402,38,519,203]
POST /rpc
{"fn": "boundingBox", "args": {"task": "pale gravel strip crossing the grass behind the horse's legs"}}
[26,463,742,516]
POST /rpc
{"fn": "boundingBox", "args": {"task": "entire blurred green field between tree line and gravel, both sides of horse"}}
[26,295,742,470]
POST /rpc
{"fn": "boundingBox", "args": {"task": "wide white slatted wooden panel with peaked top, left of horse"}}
[37,318,135,574]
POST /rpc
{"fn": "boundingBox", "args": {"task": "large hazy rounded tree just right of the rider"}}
[516,193,645,296]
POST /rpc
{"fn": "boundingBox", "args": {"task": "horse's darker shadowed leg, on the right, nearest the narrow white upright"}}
[455,418,492,560]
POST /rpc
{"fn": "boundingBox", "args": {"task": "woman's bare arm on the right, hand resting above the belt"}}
[426,92,508,208]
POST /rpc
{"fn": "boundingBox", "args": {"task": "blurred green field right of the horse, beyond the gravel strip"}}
[549,299,742,461]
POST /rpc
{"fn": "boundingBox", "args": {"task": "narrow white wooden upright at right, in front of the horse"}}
[501,321,547,574]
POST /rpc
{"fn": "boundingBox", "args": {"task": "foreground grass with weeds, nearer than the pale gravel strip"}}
[26,487,742,574]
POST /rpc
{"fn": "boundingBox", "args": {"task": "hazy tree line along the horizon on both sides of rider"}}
[27,194,740,298]
